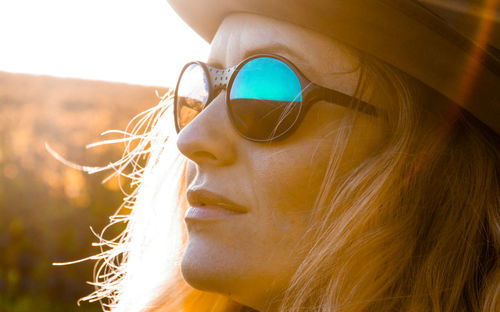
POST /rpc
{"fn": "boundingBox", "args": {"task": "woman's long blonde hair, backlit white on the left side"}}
[85,57,500,312]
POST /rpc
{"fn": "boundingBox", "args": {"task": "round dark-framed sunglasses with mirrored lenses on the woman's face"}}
[174,54,377,142]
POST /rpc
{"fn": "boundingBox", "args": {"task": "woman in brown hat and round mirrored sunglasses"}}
[84,0,500,312]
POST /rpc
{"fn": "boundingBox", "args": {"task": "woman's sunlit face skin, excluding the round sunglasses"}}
[177,14,382,310]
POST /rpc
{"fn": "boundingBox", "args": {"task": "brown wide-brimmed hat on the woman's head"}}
[168,0,500,134]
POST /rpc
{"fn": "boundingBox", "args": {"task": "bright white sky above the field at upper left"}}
[0,0,208,86]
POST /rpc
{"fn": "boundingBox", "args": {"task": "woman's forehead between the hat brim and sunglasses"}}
[208,14,359,94]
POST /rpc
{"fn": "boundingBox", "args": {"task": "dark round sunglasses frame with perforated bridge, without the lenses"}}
[174,54,378,142]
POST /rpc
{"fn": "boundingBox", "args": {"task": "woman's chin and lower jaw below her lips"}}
[181,235,293,308]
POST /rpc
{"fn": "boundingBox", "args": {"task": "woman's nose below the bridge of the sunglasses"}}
[177,92,239,166]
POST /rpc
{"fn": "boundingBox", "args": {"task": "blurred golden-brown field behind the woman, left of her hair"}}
[0,72,166,312]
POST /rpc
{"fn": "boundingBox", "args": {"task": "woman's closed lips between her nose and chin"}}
[184,188,248,222]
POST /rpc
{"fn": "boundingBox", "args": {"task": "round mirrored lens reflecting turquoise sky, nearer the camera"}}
[228,57,302,141]
